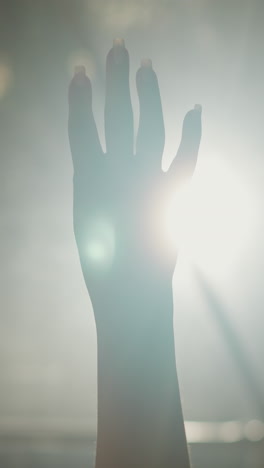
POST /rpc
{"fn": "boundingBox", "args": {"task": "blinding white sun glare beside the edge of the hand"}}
[166,159,255,282]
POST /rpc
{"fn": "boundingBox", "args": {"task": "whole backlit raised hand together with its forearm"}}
[69,40,201,468]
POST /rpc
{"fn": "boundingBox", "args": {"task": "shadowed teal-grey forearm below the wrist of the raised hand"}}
[97,298,189,468]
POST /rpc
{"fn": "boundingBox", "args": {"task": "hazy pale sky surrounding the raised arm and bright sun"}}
[0,0,264,420]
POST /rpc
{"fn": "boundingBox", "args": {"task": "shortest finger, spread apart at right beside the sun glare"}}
[168,104,202,184]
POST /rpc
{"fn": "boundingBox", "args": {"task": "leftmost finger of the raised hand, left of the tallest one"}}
[68,66,102,174]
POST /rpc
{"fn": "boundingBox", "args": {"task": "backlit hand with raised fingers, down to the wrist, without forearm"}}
[69,44,201,304]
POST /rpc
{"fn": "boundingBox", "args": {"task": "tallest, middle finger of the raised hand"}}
[105,39,134,157]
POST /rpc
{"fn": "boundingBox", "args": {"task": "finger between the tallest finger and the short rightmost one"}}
[136,59,165,168]
